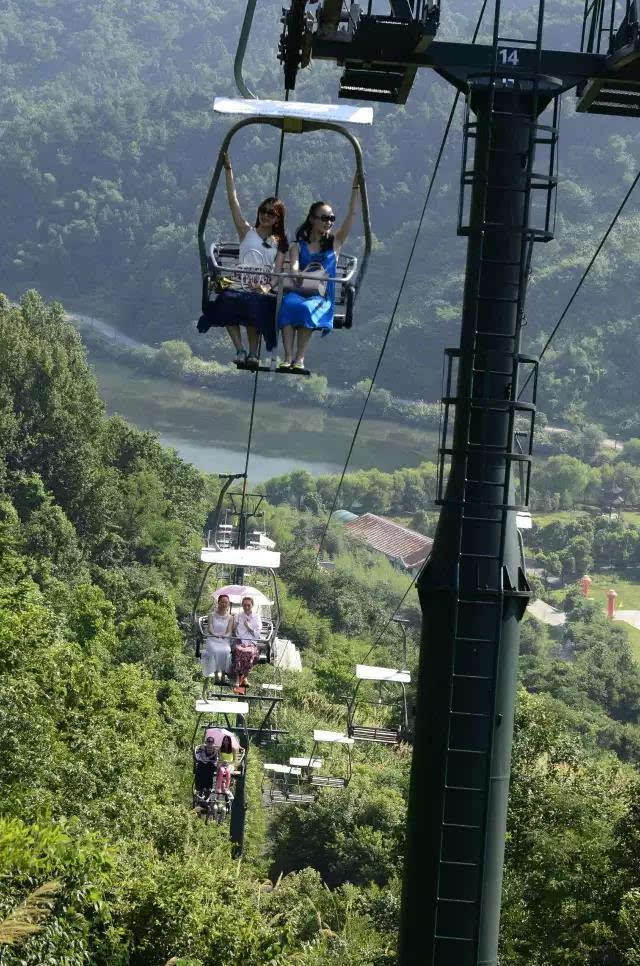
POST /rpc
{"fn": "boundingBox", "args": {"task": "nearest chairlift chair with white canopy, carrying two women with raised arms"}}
[198,97,373,375]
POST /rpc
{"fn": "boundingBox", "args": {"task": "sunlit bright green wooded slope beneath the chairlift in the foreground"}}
[0,293,640,966]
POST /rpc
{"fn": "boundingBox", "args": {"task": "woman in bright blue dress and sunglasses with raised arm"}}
[278,177,360,371]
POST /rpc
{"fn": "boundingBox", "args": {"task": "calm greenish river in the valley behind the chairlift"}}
[68,313,437,483]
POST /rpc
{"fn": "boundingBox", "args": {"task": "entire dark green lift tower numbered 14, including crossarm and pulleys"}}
[280,0,640,966]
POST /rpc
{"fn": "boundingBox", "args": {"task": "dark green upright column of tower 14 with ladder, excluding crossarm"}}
[400,0,559,966]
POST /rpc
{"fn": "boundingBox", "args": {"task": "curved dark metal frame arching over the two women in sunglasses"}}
[198,117,372,292]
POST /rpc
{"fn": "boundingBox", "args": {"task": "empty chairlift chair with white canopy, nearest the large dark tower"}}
[347,664,411,745]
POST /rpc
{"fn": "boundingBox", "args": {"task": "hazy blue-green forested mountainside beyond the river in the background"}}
[0,0,640,435]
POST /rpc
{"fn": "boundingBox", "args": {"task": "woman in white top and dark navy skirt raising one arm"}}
[198,154,289,366]
